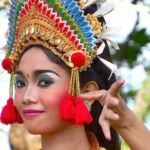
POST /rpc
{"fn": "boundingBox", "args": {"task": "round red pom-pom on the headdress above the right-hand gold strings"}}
[70,51,85,67]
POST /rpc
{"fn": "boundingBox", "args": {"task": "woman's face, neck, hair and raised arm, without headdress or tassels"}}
[12,45,150,150]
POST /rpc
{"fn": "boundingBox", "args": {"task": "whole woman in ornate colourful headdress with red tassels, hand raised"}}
[1,0,150,150]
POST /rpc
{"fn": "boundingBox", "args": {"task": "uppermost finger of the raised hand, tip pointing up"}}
[109,80,124,96]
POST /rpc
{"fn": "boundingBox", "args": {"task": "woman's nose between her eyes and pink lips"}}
[23,86,38,104]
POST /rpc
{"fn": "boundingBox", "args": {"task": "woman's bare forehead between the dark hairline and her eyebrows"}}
[16,47,68,76]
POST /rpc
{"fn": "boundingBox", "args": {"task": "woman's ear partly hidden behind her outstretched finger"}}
[81,81,99,93]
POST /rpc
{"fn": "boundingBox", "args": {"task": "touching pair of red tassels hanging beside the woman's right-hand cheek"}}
[60,93,93,125]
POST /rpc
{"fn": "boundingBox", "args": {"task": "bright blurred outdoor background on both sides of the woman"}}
[0,0,150,150]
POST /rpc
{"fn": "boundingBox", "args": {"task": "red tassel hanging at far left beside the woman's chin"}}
[0,97,22,125]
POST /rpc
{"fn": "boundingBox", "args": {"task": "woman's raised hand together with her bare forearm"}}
[81,80,150,150]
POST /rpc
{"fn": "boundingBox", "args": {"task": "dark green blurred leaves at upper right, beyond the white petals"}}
[113,28,150,68]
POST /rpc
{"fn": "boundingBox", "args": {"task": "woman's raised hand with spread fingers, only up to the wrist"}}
[81,80,130,140]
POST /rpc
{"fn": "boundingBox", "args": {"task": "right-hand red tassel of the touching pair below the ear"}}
[75,97,93,125]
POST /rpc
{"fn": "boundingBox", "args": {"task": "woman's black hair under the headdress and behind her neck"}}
[20,44,120,150]
